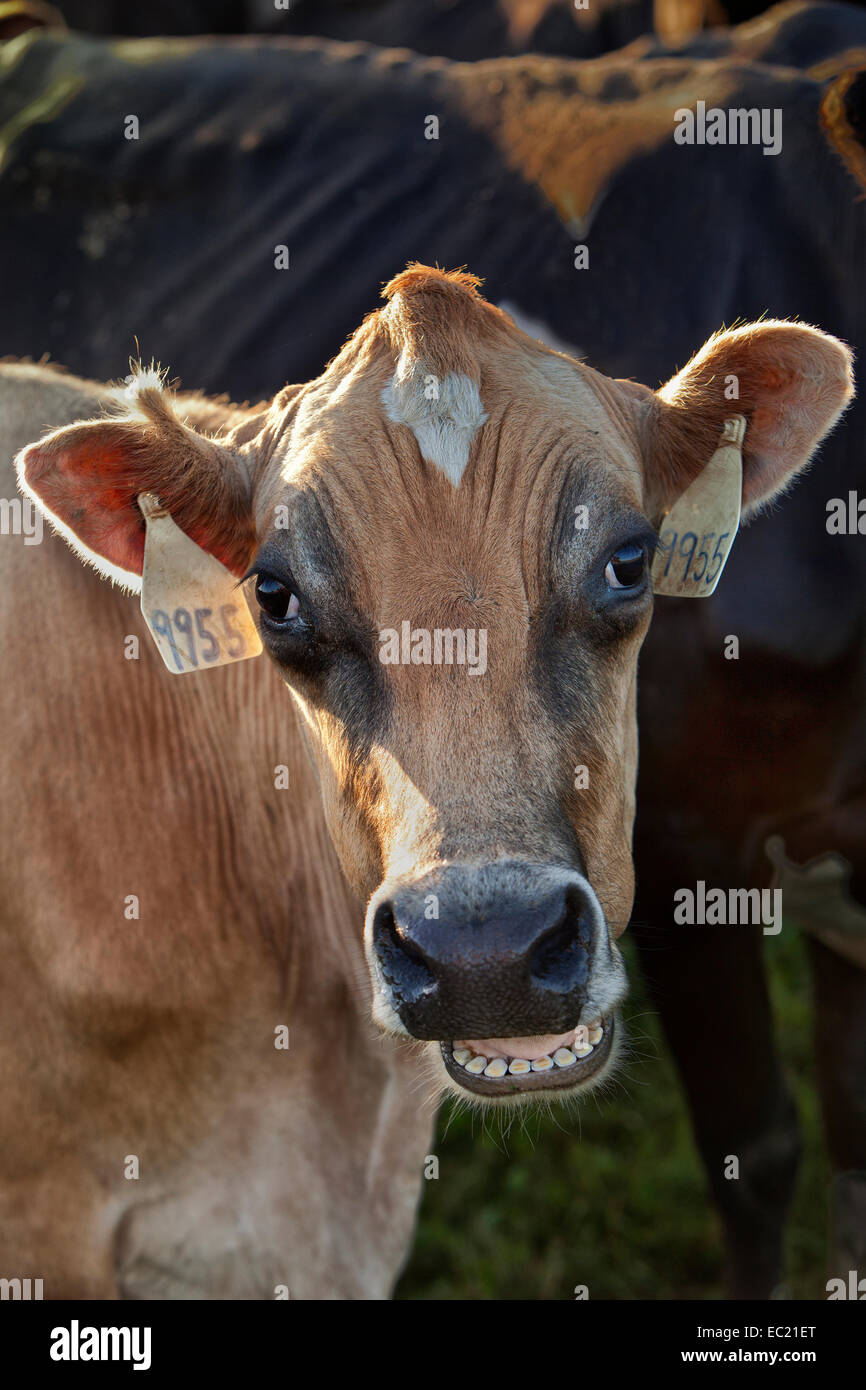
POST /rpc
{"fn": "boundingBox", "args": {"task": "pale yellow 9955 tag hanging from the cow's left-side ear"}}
[138,492,261,676]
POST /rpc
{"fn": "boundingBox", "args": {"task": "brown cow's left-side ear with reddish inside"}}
[15,378,261,592]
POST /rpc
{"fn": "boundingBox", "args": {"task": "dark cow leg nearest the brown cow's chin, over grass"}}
[635,917,799,1298]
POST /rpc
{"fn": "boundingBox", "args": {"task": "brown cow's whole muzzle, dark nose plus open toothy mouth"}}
[366,860,627,1099]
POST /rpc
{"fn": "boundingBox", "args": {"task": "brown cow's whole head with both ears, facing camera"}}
[19,267,851,1101]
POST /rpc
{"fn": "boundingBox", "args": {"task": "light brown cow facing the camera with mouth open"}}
[0,265,852,1298]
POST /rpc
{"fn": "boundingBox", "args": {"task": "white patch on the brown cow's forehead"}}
[382,353,487,487]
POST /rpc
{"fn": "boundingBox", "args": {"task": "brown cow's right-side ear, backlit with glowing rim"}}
[646,320,853,520]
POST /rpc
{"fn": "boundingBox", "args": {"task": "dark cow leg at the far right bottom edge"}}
[808,937,866,1280]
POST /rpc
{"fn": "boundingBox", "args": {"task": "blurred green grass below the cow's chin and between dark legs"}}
[396,931,828,1300]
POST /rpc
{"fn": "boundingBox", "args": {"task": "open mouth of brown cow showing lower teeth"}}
[439,1016,614,1098]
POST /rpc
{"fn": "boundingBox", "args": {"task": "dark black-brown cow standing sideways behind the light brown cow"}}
[0,6,866,1294]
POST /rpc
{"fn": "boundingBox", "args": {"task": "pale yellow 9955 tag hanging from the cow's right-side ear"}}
[652,416,745,599]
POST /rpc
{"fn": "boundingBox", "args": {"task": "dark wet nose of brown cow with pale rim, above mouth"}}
[371,866,606,1040]
